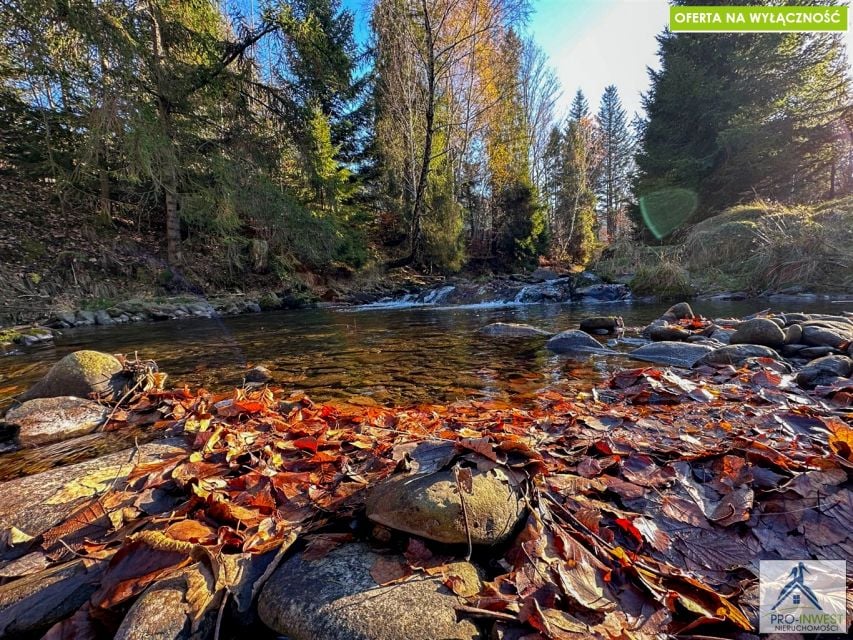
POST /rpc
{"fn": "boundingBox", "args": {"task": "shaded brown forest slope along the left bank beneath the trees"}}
[0,174,436,326]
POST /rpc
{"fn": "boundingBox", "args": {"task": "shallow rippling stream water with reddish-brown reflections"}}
[0,300,846,476]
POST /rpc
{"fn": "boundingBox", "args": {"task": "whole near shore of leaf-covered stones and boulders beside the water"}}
[0,303,853,640]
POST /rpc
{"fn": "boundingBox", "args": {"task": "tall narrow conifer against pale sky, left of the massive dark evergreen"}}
[596,85,634,242]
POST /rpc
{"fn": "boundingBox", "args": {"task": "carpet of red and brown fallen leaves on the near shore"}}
[15,360,853,640]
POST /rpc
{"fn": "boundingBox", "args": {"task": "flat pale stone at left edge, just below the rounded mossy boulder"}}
[0,396,110,446]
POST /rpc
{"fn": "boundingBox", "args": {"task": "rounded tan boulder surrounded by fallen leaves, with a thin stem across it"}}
[366,467,525,545]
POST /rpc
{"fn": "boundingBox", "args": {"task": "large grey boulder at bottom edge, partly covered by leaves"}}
[258,544,481,640]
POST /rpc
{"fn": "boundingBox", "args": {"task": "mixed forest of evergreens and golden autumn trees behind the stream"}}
[0,0,853,302]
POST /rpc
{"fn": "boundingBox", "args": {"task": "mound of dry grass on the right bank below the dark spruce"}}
[604,197,853,297]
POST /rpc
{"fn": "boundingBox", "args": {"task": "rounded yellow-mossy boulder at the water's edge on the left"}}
[19,350,127,400]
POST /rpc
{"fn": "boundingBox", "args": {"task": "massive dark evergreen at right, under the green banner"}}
[634,0,851,230]
